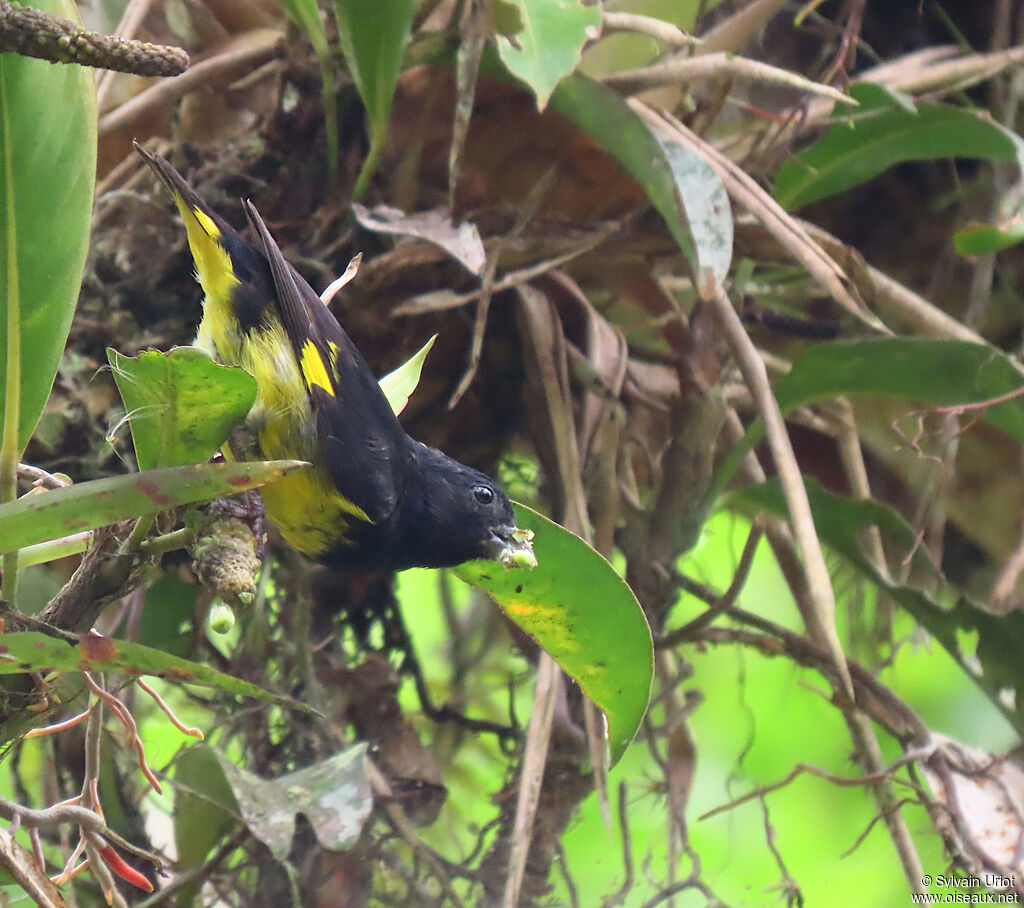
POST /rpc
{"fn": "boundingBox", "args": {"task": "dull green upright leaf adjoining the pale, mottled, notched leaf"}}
[174,744,240,908]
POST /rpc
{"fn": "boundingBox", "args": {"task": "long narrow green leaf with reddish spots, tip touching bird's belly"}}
[0,461,306,553]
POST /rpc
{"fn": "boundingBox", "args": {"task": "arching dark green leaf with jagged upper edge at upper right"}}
[775,82,1024,209]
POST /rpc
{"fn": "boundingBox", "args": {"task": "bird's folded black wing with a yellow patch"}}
[245,202,414,523]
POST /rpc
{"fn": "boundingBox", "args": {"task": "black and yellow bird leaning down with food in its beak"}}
[135,144,536,570]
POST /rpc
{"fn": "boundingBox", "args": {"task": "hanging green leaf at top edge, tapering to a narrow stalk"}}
[334,0,417,200]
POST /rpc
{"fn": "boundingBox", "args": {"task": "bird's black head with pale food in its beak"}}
[400,444,537,567]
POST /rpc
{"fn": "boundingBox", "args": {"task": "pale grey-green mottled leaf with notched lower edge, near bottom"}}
[205,744,374,861]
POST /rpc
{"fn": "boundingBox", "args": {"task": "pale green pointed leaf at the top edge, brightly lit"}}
[498,0,601,111]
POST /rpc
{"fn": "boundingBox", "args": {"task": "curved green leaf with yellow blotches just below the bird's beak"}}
[454,504,654,764]
